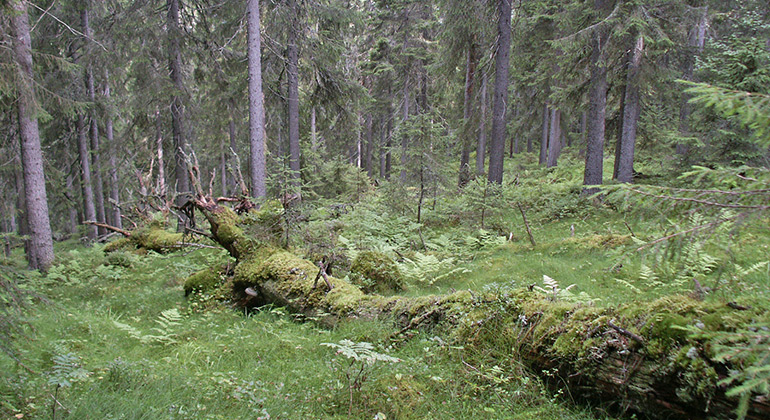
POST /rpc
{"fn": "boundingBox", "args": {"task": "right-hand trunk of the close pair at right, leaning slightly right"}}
[616,35,644,182]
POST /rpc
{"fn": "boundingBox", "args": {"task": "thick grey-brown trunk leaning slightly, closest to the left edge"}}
[9,0,53,270]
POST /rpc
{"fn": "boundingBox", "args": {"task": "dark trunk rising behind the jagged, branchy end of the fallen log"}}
[166,0,190,213]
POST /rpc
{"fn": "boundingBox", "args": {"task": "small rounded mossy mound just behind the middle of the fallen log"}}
[350,251,404,293]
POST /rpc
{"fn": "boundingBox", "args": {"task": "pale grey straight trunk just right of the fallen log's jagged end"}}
[248,0,268,198]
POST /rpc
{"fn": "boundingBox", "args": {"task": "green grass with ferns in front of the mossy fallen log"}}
[0,241,608,420]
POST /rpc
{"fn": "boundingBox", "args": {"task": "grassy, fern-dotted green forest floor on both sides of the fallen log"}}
[0,156,770,419]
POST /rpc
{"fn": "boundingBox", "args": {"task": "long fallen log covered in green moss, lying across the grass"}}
[188,200,770,419]
